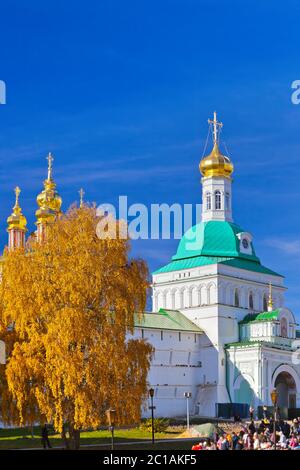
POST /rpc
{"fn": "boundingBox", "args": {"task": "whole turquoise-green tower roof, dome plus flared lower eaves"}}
[153,220,282,277]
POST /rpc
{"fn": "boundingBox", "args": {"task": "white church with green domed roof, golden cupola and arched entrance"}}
[135,115,300,417]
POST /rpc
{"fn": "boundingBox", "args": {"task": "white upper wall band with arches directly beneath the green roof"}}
[152,264,285,315]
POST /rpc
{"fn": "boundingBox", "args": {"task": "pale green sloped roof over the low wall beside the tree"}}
[134,308,202,333]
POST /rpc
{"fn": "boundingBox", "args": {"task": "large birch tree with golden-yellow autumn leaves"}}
[0,205,152,448]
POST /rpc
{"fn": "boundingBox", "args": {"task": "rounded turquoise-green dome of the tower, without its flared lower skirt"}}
[172,220,259,261]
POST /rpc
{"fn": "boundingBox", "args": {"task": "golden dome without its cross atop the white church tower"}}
[199,142,234,178]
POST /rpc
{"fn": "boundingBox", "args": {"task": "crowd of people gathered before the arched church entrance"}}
[192,417,300,450]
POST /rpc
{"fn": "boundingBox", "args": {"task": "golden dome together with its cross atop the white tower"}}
[199,112,234,178]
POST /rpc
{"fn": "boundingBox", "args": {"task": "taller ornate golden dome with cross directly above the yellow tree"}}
[35,153,62,221]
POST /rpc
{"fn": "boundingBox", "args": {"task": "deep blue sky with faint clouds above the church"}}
[0,0,300,314]
